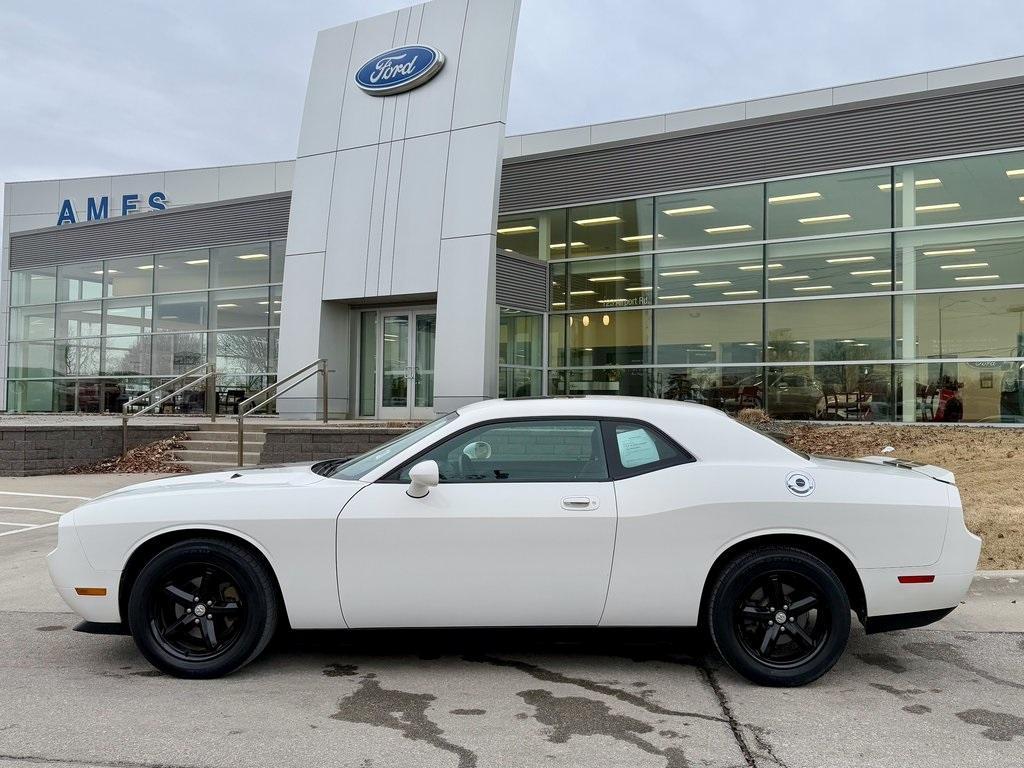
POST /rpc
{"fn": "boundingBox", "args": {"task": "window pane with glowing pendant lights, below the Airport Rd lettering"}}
[567,309,651,367]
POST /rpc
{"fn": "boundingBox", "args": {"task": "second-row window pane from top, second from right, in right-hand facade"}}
[767,234,893,299]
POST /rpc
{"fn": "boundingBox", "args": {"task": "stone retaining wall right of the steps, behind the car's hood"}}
[259,425,412,464]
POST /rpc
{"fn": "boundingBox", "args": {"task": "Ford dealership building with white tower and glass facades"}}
[0,0,1024,422]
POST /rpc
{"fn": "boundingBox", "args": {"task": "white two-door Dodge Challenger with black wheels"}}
[48,397,981,685]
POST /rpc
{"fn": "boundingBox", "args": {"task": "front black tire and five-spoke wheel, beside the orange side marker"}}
[128,539,280,679]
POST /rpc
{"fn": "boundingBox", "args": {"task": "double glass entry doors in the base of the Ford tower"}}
[377,310,437,419]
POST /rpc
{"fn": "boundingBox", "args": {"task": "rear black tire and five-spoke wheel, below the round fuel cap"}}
[707,547,850,686]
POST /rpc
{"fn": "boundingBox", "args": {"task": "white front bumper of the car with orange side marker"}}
[46,512,121,624]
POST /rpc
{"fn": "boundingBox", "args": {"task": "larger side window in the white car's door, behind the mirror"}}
[398,419,608,482]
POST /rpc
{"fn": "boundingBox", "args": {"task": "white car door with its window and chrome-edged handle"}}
[337,419,615,628]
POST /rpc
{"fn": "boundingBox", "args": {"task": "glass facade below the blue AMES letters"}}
[7,241,284,413]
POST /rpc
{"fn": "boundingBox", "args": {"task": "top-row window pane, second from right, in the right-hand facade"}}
[766,168,892,240]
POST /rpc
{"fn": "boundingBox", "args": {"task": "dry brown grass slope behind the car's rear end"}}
[774,423,1024,569]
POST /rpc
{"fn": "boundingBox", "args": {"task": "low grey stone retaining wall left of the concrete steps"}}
[0,422,197,477]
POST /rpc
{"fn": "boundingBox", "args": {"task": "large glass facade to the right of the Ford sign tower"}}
[497,147,1024,422]
